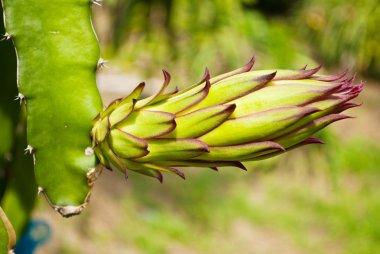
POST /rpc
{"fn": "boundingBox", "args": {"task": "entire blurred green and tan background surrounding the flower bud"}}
[34,0,380,254]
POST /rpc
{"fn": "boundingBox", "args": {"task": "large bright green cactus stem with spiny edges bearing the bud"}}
[2,0,102,216]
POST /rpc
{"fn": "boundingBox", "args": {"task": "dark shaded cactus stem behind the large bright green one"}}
[0,5,37,236]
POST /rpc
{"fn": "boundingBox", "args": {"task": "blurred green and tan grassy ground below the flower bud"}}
[52,132,380,254]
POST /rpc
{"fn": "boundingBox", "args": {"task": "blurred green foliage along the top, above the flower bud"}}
[98,0,380,78]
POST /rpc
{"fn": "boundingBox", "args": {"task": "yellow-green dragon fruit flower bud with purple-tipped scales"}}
[91,61,363,181]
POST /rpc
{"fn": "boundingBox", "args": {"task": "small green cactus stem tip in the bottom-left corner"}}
[0,207,16,254]
